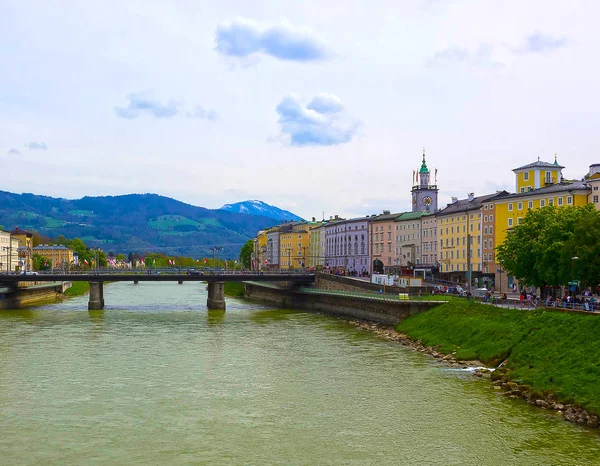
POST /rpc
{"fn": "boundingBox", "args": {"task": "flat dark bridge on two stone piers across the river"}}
[0,271,315,310]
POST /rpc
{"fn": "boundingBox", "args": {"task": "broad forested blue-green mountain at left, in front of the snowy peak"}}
[0,191,279,258]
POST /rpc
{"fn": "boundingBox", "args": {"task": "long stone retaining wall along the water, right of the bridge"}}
[246,284,441,325]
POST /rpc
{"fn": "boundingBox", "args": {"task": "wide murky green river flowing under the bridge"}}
[0,282,600,465]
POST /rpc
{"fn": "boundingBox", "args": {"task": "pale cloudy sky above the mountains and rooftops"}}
[0,0,600,218]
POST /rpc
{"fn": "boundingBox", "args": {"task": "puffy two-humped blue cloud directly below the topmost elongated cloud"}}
[276,94,359,146]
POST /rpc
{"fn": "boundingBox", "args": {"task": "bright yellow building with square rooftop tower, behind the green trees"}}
[494,159,592,289]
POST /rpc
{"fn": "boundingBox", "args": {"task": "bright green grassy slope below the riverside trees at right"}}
[397,301,600,414]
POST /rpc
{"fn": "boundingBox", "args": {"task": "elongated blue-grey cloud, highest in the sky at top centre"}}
[216,18,329,62]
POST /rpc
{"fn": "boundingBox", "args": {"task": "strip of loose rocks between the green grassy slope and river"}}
[350,321,600,429]
